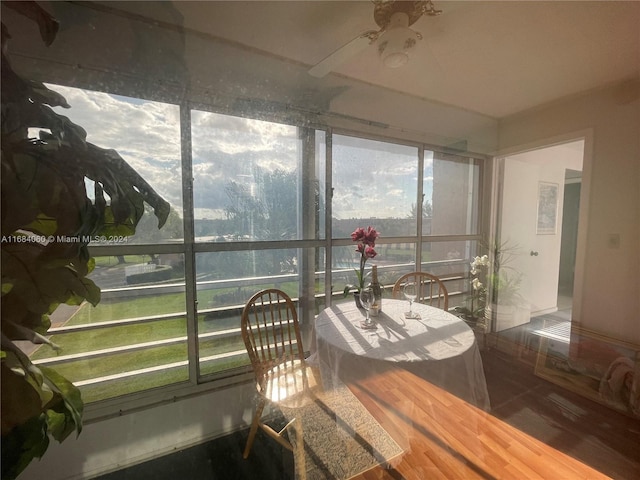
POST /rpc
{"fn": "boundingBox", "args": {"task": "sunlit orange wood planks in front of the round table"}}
[344,352,640,480]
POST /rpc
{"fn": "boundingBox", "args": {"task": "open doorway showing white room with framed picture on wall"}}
[493,140,585,332]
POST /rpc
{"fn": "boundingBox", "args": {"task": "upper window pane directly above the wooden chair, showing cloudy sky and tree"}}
[191,110,322,242]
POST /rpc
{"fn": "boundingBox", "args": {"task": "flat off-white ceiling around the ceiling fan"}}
[97,0,640,118]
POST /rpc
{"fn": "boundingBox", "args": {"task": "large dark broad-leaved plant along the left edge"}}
[1,2,170,479]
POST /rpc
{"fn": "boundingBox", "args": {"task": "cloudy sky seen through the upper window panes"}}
[49,85,432,219]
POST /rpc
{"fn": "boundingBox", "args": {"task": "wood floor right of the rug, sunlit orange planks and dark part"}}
[346,346,640,480]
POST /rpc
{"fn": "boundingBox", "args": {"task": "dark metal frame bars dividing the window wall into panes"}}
[32,94,489,422]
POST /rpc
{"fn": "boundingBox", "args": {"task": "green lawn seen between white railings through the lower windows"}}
[31,274,321,402]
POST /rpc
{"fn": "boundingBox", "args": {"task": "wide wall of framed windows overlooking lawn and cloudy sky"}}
[29,86,481,403]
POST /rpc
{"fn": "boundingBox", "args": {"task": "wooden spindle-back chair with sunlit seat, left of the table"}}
[241,289,321,475]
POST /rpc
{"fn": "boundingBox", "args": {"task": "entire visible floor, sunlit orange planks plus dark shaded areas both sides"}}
[96,340,640,480]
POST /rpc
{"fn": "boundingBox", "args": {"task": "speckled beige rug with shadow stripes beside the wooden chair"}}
[283,384,402,480]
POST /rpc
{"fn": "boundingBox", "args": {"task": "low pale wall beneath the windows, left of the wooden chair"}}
[20,383,255,480]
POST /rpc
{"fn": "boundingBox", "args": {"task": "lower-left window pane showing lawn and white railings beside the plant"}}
[31,254,189,402]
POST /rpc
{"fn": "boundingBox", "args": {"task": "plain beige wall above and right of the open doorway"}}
[498,78,640,343]
